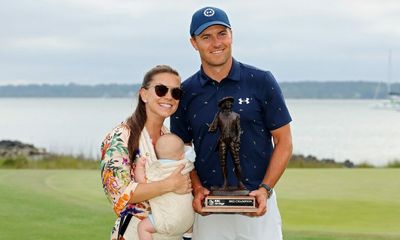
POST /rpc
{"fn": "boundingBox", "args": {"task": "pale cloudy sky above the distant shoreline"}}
[0,0,400,85]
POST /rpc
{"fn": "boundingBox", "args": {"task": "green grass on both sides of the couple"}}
[0,169,400,240]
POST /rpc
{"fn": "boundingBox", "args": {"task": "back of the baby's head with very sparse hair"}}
[155,133,185,160]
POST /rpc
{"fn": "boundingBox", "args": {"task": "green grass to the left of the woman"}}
[0,170,115,240]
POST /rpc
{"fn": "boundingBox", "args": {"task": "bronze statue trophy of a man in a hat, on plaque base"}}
[202,97,257,213]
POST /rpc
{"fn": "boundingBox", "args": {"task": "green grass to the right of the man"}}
[277,169,400,239]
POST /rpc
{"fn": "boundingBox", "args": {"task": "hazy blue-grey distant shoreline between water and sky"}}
[0,81,400,99]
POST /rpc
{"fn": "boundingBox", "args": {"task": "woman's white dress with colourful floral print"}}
[100,123,150,240]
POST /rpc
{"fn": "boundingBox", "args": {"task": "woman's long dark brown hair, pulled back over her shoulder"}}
[126,65,179,163]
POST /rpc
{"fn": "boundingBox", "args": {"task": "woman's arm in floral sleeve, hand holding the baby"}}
[101,125,191,215]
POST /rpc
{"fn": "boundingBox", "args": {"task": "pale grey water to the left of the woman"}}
[0,98,136,157]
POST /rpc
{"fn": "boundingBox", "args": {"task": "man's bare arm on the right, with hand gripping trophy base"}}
[249,124,293,216]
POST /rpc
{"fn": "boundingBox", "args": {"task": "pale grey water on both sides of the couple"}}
[0,98,400,165]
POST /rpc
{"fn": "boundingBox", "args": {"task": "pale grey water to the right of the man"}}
[287,100,400,165]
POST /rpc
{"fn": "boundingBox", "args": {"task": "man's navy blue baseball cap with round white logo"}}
[190,7,231,36]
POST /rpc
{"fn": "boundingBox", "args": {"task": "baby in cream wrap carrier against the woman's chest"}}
[135,133,194,240]
